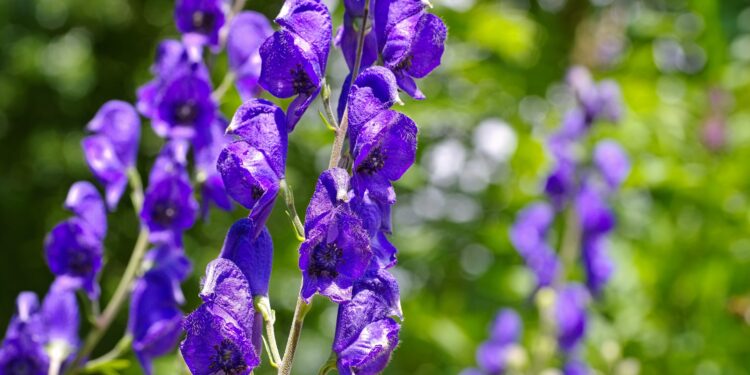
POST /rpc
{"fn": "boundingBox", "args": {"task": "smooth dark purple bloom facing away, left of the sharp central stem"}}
[219,219,273,297]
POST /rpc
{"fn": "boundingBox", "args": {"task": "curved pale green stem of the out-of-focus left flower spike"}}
[66,169,148,374]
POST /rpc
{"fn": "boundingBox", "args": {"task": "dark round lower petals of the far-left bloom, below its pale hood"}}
[44,218,103,300]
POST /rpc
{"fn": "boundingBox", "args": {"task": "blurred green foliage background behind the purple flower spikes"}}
[0,0,750,375]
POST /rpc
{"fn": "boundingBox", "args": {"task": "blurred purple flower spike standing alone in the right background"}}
[510,67,630,374]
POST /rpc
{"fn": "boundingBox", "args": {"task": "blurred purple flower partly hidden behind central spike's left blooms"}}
[193,117,232,220]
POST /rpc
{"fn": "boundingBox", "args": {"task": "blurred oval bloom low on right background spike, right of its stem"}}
[555,284,588,352]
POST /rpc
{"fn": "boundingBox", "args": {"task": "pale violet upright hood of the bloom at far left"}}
[65,181,107,238]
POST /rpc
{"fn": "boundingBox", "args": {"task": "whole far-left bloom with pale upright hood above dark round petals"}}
[44,182,107,299]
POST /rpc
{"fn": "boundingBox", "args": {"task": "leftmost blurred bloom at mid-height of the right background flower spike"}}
[510,202,559,288]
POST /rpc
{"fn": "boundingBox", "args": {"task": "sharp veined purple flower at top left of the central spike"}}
[259,0,332,131]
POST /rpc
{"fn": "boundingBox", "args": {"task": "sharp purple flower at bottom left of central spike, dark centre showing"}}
[180,258,260,375]
